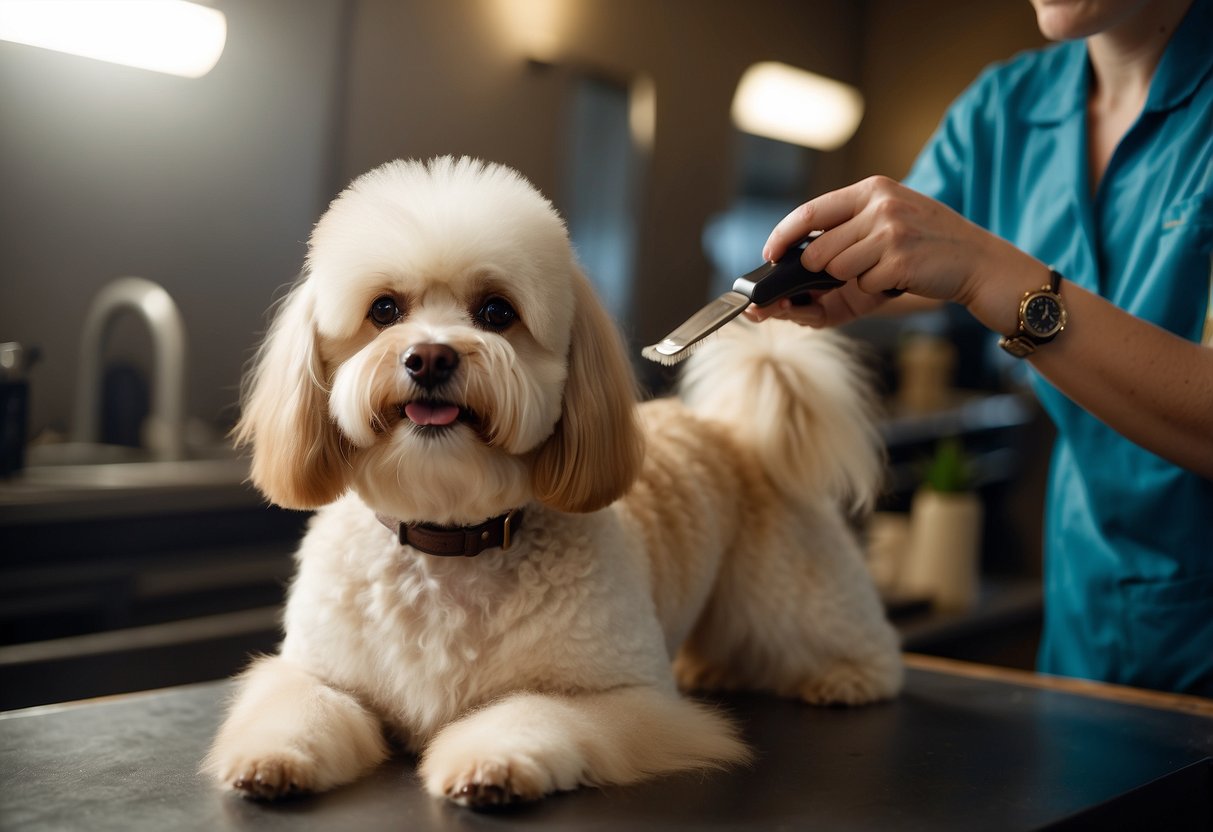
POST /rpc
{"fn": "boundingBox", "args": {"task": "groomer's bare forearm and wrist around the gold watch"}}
[967,260,1213,479]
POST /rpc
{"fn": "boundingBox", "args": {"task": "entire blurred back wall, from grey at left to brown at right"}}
[0,0,1037,439]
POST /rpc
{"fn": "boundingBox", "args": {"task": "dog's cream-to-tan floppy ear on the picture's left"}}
[233,281,347,508]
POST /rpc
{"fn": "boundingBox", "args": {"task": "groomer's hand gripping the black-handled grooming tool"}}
[746,176,1047,332]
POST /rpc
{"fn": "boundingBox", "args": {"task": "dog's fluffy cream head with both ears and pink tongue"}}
[235,158,643,523]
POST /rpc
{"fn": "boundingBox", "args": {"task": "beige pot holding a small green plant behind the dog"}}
[901,489,983,611]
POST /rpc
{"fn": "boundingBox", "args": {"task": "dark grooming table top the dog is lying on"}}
[0,661,1213,832]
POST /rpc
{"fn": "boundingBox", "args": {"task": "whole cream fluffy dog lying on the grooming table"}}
[205,158,901,807]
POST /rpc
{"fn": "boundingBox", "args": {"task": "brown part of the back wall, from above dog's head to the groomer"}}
[338,0,1038,354]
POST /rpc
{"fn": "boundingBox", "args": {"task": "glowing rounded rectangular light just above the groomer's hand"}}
[733,62,864,150]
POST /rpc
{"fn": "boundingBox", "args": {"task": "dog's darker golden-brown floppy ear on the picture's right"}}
[531,272,644,512]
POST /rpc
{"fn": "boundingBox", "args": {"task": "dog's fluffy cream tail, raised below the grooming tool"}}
[679,319,884,511]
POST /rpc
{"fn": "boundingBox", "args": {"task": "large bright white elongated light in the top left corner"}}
[0,0,227,78]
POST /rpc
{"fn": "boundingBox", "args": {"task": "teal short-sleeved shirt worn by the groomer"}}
[906,0,1213,696]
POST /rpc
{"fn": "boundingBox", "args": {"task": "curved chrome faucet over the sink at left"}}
[72,278,186,460]
